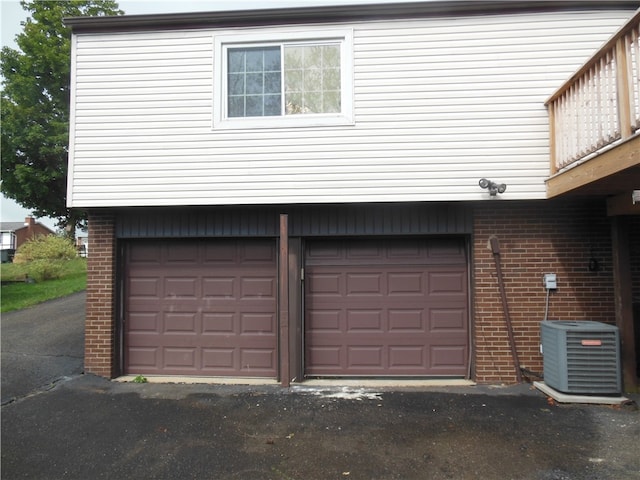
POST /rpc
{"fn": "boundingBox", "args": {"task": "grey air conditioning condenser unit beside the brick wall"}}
[540,320,622,395]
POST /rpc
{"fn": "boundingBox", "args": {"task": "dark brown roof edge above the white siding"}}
[64,0,640,32]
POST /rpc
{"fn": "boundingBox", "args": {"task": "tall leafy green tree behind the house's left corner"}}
[0,0,124,231]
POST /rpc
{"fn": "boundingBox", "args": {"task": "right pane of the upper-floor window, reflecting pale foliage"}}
[284,44,341,115]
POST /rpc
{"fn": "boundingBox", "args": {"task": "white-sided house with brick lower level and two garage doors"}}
[66,0,640,388]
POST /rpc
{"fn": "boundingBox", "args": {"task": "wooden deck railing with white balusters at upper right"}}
[546,10,640,175]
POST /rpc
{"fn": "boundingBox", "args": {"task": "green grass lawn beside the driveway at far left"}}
[0,258,87,312]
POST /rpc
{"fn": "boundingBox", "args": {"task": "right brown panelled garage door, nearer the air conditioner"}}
[305,238,469,376]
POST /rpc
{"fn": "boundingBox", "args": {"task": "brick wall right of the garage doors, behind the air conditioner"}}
[473,200,615,383]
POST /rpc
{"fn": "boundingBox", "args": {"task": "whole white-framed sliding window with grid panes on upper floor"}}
[214,30,353,128]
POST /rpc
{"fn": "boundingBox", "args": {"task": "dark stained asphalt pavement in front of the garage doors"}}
[1,292,640,480]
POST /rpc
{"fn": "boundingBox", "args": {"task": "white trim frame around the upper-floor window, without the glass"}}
[213,29,354,129]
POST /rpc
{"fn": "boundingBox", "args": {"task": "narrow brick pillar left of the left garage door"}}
[84,211,116,378]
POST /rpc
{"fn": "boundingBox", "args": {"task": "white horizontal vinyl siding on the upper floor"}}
[68,11,632,207]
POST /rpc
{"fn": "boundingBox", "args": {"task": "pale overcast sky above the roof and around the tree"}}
[0,0,416,228]
